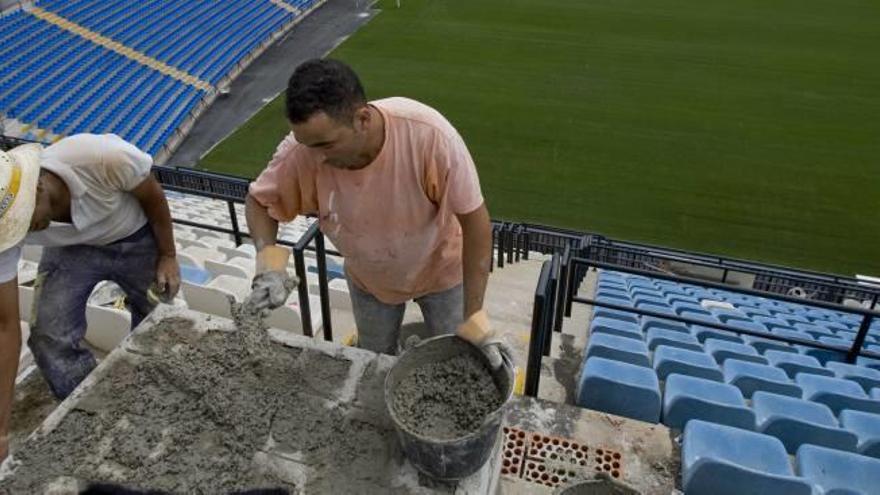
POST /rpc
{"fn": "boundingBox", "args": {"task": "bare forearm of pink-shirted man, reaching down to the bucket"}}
[457,203,492,320]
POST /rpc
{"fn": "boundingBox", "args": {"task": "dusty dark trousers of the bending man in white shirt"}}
[28,224,158,399]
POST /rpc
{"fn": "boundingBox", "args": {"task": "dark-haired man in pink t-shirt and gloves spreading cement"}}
[247,59,510,367]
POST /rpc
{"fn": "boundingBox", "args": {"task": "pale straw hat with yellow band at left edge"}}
[0,144,43,252]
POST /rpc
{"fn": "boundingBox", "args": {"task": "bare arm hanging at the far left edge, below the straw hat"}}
[0,278,21,462]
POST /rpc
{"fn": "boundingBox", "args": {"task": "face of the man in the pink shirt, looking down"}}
[291,107,369,169]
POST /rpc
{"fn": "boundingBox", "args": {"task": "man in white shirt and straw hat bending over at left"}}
[0,134,180,460]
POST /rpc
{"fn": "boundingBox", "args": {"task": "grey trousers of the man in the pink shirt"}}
[348,280,464,355]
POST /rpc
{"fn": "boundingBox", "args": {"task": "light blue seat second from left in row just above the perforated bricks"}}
[662,375,755,430]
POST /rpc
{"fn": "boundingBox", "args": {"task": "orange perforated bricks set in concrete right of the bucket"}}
[501,427,623,488]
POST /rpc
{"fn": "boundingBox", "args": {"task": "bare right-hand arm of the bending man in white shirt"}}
[131,176,180,299]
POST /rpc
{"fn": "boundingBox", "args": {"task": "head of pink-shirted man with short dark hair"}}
[286,59,377,169]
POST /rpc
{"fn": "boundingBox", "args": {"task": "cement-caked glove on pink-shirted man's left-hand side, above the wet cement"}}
[245,246,299,312]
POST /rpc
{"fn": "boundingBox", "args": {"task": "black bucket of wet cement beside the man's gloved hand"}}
[385,335,514,481]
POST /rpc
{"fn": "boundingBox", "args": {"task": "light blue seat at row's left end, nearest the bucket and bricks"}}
[577,357,660,423]
